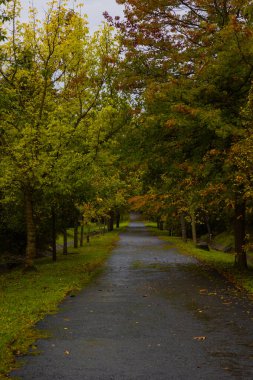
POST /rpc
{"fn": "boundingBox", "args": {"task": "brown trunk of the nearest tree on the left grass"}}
[25,191,37,270]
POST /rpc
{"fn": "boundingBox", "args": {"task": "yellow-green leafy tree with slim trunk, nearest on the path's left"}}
[0,0,122,267]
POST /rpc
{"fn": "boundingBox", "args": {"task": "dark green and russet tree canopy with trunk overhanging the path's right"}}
[107,0,253,267]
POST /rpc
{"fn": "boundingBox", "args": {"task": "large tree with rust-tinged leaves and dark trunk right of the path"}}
[111,0,253,268]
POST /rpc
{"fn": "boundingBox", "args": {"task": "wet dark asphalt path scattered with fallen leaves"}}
[12,222,253,380]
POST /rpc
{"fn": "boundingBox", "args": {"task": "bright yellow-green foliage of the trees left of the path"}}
[0,0,132,265]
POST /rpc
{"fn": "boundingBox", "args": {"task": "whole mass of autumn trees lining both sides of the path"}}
[0,0,253,270]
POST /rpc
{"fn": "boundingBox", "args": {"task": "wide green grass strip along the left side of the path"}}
[0,227,126,379]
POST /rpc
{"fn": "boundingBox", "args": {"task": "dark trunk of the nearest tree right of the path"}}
[234,197,247,269]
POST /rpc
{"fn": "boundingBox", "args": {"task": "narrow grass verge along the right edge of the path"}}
[146,222,253,298]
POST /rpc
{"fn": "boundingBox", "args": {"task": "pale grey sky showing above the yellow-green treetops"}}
[21,0,123,32]
